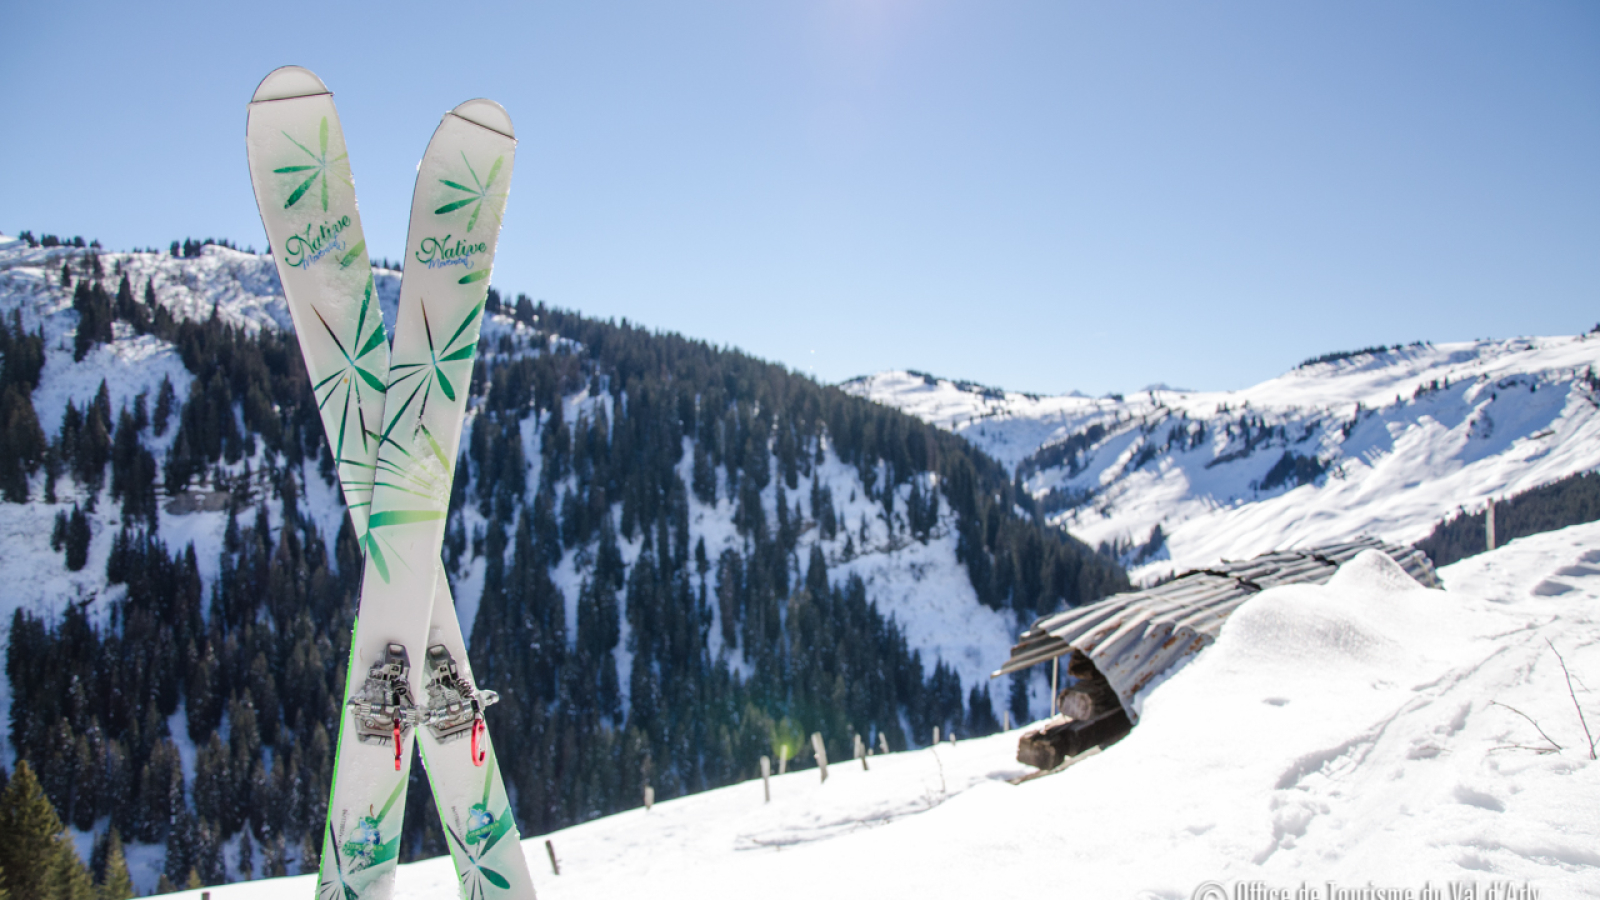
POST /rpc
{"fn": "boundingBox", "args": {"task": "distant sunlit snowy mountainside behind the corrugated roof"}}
[843,333,1600,580]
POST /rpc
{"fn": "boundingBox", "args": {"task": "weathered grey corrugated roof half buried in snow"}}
[994,538,1440,722]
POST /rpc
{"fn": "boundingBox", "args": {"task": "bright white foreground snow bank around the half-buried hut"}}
[179,524,1600,900]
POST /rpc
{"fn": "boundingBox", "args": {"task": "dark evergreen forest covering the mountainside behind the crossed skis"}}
[0,251,1126,884]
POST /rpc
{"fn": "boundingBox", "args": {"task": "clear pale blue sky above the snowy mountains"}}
[0,0,1600,394]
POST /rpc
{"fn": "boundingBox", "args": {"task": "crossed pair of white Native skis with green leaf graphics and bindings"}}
[246,66,534,900]
